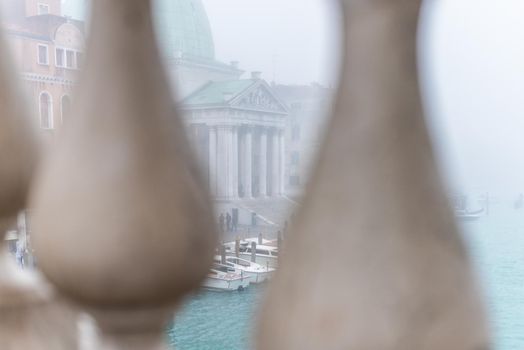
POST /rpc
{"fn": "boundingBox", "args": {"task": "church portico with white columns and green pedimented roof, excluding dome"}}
[180,73,288,200]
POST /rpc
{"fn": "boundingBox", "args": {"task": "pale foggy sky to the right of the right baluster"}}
[420,0,524,196]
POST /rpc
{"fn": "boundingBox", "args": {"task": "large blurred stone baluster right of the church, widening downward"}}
[257,0,489,350]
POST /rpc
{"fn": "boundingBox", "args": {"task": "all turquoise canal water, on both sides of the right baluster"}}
[168,201,524,350]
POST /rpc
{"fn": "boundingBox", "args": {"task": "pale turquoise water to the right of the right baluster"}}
[463,203,524,350]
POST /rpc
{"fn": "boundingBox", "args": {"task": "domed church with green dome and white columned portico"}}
[61,0,288,202]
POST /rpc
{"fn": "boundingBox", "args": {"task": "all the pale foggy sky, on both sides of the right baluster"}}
[23,0,524,196]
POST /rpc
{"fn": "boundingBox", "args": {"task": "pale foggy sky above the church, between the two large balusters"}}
[203,0,339,85]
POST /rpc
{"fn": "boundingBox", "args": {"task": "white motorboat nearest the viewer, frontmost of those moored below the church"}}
[202,263,251,291]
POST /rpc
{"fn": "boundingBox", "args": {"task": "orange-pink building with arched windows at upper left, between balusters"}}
[3,0,85,133]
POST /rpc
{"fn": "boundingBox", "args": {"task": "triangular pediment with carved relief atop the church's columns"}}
[229,81,288,113]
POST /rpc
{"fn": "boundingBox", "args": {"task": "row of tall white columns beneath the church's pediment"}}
[189,124,285,200]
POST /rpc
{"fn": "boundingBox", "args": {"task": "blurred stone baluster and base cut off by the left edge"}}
[0,17,76,350]
